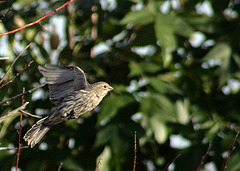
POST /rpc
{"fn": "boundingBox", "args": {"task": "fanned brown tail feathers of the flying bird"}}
[23,116,51,148]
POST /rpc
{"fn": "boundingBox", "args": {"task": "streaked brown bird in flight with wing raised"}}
[23,64,113,148]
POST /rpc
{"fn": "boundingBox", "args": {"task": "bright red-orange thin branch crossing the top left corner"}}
[0,0,75,36]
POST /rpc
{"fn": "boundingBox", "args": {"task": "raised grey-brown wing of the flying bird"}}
[38,64,88,104]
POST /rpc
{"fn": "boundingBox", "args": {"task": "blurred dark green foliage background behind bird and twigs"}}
[0,0,240,171]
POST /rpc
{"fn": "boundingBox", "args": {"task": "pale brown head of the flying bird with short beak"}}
[92,82,113,97]
